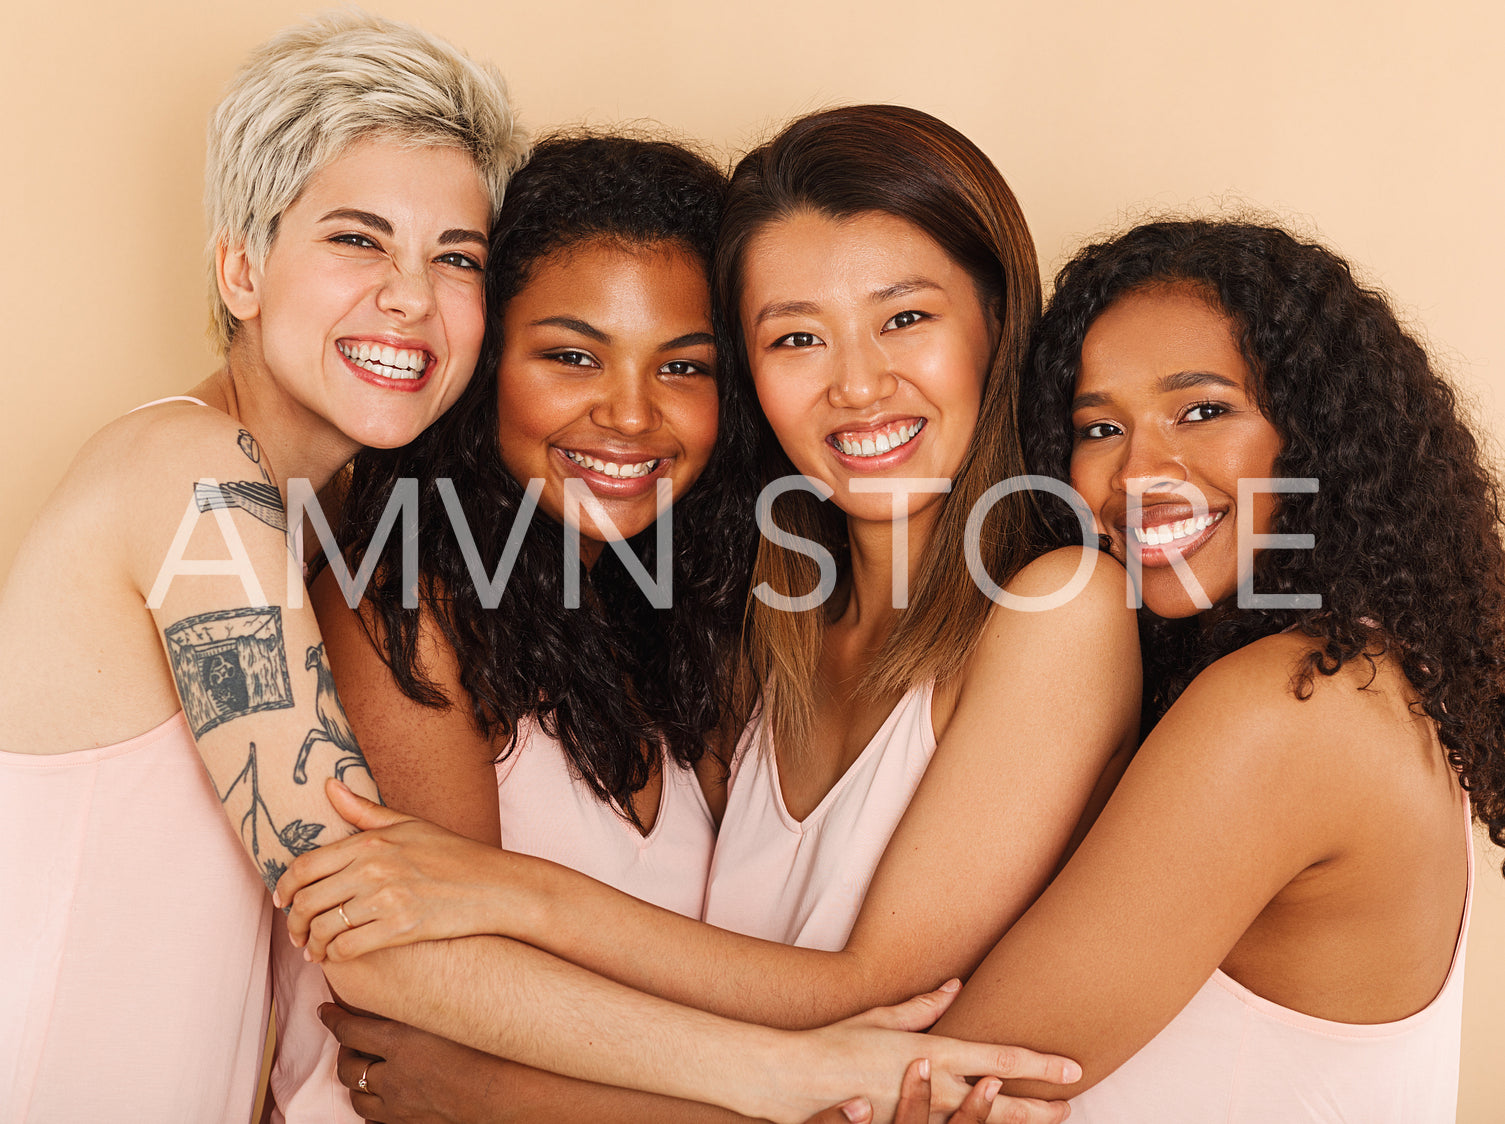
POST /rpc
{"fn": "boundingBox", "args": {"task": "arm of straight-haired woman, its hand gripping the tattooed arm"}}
[289,551,1139,1028]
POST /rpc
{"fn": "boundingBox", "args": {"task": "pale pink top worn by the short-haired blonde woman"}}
[0,712,271,1124]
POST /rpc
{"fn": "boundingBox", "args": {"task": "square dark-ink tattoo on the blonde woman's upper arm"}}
[163,605,294,737]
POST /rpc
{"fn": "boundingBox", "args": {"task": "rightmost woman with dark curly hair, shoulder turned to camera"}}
[909,221,1505,1124]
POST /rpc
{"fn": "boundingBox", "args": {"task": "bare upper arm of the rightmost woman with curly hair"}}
[938,649,1373,1095]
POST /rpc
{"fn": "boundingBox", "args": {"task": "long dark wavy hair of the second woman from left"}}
[340,135,756,819]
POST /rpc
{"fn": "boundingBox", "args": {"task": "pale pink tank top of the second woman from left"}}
[272,721,716,1124]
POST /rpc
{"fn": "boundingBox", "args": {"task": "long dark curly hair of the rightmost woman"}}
[1020,221,1505,860]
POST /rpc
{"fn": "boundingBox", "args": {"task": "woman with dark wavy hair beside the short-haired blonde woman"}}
[274,135,754,1124]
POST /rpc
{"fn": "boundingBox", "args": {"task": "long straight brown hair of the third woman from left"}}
[712,105,1046,749]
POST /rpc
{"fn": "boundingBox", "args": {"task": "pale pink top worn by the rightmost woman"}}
[1072,810,1473,1124]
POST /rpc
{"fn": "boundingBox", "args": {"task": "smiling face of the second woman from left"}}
[497,242,716,561]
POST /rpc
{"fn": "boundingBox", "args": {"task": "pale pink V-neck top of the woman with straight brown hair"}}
[703,683,936,951]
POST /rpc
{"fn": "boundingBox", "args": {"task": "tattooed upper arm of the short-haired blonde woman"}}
[125,411,376,888]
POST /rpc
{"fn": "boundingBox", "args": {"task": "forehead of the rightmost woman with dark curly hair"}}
[1076,284,1252,394]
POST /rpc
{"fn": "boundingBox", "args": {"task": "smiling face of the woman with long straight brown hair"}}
[742,212,998,530]
